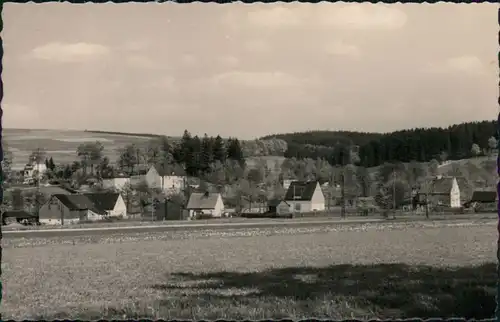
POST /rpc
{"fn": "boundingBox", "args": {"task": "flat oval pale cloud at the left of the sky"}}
[32,42,110,63]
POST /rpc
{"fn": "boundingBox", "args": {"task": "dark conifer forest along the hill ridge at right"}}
[264,121,498,167]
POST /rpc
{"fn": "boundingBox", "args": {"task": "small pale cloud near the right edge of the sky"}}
[424,55,485,75]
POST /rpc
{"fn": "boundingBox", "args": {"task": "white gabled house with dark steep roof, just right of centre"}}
[277,181,325,213]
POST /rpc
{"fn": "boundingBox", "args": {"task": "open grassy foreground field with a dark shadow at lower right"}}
[2,220,497,319]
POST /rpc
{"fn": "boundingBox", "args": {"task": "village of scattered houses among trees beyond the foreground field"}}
[2,142,497,226]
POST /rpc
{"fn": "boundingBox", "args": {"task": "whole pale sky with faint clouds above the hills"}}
[2,3,499,139]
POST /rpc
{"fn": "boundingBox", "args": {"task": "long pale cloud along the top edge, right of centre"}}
[224,3,407,30]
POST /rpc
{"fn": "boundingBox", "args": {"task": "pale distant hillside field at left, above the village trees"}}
[2,129,155,169]
